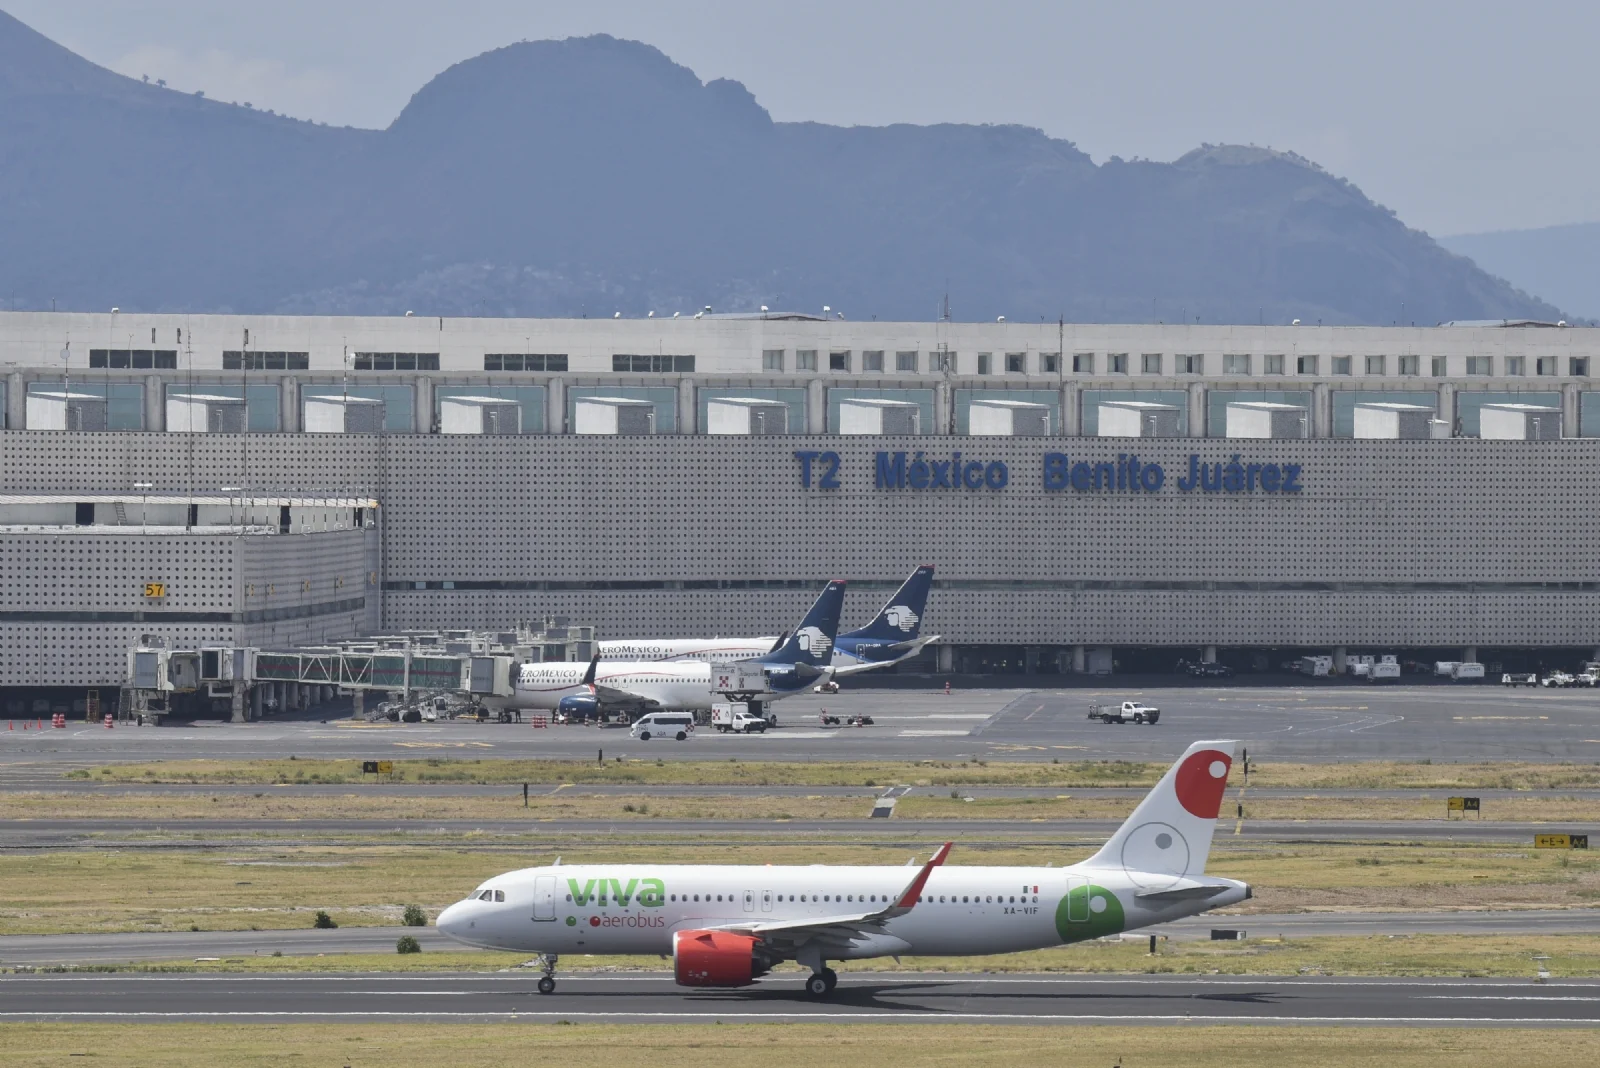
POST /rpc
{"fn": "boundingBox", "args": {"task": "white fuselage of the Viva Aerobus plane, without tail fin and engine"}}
[440,865,1250,959]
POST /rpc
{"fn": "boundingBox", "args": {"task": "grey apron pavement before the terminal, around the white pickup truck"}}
[0,681,1600,767]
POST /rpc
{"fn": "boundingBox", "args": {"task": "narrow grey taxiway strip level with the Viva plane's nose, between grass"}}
[0,908,1600,967]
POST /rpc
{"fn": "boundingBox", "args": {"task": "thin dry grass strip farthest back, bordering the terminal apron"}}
[69,754,1600,790]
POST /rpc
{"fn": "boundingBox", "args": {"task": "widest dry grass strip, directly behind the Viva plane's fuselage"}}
[0,833,1600,934]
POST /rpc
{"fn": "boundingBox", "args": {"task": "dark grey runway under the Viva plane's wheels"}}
[0,970,1600,1026]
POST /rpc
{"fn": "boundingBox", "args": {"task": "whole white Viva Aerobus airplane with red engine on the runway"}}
[438,742,1250,998]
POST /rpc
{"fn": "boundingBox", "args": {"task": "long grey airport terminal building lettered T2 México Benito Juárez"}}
[0,312,1600,686]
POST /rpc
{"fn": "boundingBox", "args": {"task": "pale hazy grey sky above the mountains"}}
[9,0,1600,235]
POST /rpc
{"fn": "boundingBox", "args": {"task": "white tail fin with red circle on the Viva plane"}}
[1082,742,1238,891]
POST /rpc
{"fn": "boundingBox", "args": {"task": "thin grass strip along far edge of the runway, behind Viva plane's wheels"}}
[68,919,1600,978]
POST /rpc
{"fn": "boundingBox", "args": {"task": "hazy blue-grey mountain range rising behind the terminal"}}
[0,13,1560,325]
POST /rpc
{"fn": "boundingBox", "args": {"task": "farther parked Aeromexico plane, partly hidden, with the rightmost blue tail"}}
[600,564,939,676]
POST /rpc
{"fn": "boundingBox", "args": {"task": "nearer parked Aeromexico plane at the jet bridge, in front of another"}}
[502,579,845,719]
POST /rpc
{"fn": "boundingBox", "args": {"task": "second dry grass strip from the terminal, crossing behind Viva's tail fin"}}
[0,785,1600,833]
